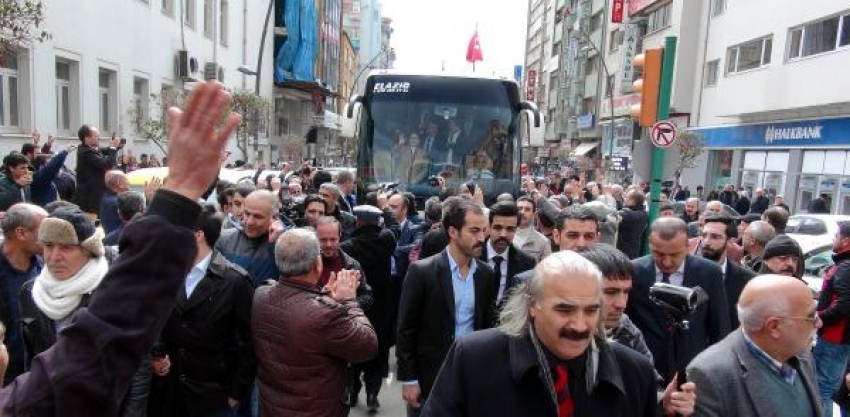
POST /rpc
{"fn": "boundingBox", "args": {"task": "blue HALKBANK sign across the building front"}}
[688,118,850,149]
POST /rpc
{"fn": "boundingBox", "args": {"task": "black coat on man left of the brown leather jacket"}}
[151,252,257,416]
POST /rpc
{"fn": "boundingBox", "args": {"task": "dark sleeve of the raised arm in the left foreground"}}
[0,189,201,416]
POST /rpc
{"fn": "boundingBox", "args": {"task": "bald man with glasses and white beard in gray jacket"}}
[688,275,822,417]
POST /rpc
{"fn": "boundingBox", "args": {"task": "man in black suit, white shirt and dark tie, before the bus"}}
[481,202,537,304]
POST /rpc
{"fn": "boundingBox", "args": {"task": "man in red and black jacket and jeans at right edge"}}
[812,222,850,416]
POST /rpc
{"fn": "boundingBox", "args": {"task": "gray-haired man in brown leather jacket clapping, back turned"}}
[251,229,378,416]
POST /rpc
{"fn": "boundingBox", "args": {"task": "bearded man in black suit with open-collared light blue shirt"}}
[396,199,498,416]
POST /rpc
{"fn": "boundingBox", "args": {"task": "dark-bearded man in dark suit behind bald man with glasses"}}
[701,213,756,329]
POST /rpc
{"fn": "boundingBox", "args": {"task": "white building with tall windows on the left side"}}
[0,0,274,167]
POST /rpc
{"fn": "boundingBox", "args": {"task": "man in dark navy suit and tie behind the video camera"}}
[626,217,729,381]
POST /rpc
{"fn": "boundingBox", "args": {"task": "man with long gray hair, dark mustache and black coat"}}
[422,251,676,417]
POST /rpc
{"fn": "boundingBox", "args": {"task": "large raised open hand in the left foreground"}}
[164,81,239,200]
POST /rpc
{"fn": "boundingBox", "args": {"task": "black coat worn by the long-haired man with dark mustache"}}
[422,329,656,417]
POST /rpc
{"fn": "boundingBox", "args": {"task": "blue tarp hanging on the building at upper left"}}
[274,0,319,83]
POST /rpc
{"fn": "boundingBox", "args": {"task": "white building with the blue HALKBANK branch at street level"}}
[683,0,850,214]
